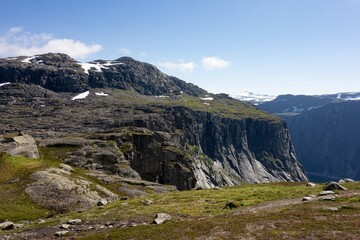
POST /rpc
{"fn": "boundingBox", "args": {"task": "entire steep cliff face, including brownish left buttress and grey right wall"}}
[123,107,307,189]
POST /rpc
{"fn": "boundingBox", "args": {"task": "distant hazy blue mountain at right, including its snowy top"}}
[258,92,360,181]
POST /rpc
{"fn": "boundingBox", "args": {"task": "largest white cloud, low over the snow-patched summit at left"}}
[0,27,102,58]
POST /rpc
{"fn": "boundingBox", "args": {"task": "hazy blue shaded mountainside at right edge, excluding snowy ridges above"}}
[288,101,360,180]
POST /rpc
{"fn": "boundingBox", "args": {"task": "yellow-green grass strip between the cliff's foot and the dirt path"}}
[67,183,320,227]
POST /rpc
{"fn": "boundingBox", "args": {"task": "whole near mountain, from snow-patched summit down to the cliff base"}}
[0,53,307,190]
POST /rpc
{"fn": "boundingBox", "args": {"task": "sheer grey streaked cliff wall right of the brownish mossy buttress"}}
[173,109,307,185]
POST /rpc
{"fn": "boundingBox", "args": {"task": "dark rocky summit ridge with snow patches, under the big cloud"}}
[0,53,206,96]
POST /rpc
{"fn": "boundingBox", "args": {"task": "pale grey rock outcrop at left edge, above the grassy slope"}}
[0,134,39,159]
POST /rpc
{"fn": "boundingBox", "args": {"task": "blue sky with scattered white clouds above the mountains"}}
[0,0,360,95]
